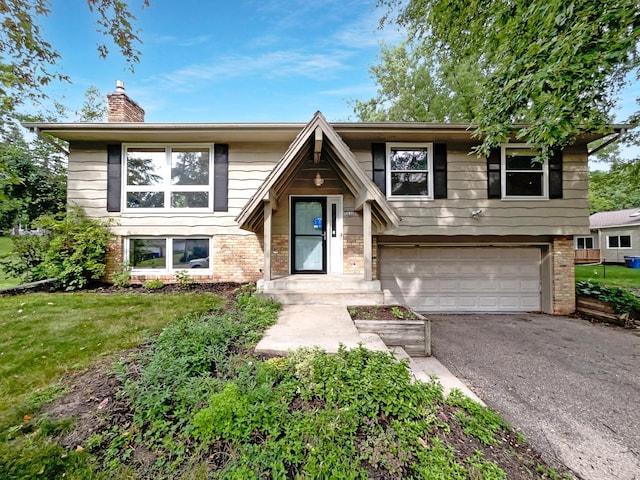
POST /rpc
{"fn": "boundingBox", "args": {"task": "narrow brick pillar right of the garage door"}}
[551,236,576,315]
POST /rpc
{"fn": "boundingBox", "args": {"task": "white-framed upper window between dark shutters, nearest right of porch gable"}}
[387,143,433,198]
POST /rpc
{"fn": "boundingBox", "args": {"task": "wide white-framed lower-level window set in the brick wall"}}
[127,237,211,273]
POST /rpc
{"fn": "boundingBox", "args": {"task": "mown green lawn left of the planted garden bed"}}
[0,292,222,426]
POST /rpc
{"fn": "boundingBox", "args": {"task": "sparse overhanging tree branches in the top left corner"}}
[0,0,149,115]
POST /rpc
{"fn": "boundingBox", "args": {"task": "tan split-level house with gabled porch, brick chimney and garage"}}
[25,84,619,314]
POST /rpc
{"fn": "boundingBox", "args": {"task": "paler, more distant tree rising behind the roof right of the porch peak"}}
[351,40,482,122]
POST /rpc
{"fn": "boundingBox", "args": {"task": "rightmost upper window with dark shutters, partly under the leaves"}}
[502,145,548,198]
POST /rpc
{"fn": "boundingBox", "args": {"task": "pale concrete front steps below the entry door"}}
[258,274,384,305]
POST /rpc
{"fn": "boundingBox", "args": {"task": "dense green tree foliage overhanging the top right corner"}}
[379,0,640,155]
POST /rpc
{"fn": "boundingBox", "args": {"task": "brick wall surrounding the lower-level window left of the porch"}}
[105,235,264,283]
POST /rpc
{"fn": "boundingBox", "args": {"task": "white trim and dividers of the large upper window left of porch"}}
[121,143,215,213]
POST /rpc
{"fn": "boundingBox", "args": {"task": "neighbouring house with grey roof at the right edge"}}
[575,208,640,263]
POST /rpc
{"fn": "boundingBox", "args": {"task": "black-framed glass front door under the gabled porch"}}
[291,197,327,273]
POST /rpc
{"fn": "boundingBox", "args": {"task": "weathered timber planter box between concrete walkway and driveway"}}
[354,314,431,357]
